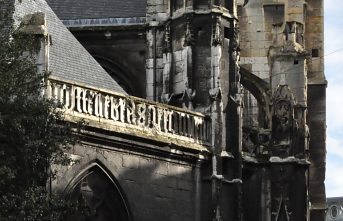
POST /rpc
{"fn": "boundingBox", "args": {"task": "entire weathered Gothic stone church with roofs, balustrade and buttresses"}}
[8,0,326,221]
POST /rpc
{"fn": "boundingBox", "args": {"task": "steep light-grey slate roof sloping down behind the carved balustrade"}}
[14,0,126,94]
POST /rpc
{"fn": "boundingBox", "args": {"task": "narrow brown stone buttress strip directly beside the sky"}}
[305,0,327,218]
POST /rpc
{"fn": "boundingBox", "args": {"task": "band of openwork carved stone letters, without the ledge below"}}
[46,80,210,144]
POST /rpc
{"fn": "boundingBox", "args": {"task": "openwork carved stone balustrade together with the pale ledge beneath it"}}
[44,78,211,151]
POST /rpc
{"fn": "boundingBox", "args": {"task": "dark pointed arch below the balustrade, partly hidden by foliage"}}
[65,161,133,221]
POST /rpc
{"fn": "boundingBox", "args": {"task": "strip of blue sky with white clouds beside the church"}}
[324,0,343,197]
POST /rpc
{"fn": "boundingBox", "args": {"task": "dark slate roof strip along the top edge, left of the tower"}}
[47,0,146,20]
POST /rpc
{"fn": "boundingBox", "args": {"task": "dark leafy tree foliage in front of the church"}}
[0,3,85,221]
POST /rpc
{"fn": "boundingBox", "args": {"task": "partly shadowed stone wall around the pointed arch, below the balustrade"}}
[53,133,203,221]
